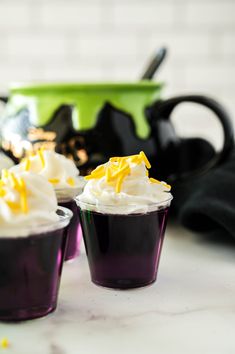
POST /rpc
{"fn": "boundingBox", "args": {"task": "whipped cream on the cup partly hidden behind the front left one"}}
[11,150,85,199]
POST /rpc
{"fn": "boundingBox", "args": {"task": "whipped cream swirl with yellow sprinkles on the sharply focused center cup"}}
[77,152,172,214]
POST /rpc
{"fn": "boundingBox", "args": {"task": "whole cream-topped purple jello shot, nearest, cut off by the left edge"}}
[0,170,72,321]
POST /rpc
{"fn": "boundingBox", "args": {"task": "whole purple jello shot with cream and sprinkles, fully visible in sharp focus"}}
[76,152,172,289]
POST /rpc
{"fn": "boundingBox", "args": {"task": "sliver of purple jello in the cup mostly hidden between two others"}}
[59,200,82,261]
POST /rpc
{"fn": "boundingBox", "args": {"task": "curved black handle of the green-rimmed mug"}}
[152,95,234,179]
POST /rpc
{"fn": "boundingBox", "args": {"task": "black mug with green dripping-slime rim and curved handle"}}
[0,81,233,180]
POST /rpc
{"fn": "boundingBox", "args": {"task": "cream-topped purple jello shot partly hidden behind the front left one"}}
[11,149,85,261]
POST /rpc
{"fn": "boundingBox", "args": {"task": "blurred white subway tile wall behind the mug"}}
[0,0,235,144]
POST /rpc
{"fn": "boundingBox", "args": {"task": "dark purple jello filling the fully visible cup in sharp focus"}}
[80,208,168,289]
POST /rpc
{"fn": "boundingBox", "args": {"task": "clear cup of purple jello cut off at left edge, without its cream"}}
[0,207,72,321]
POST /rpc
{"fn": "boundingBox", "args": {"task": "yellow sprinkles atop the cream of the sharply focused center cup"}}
[85,151,171,193]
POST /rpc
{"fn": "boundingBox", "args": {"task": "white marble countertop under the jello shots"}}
[0,225,235,354]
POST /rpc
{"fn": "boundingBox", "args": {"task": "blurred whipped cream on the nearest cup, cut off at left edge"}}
[0,172,59,237]
